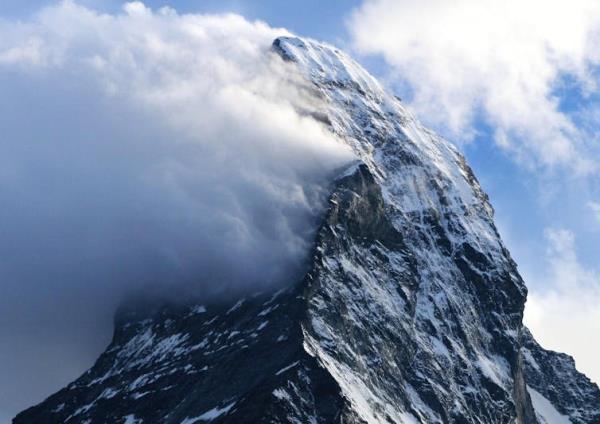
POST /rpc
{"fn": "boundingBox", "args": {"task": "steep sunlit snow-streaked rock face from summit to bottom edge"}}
[276,39,534,423]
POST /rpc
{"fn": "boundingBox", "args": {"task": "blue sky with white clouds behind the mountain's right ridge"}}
[0,0,600,418]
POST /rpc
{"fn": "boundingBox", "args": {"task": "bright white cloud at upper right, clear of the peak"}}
[348,0,600,174]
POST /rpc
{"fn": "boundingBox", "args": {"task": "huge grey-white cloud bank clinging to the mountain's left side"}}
[0,1,351,413]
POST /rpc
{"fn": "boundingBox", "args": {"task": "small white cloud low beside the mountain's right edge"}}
[524,229,600,383]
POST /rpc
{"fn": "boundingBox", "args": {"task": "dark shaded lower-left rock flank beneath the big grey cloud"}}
[14,288,345,424]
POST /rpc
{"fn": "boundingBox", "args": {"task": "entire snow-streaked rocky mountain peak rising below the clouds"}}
[14,37,600,424]
